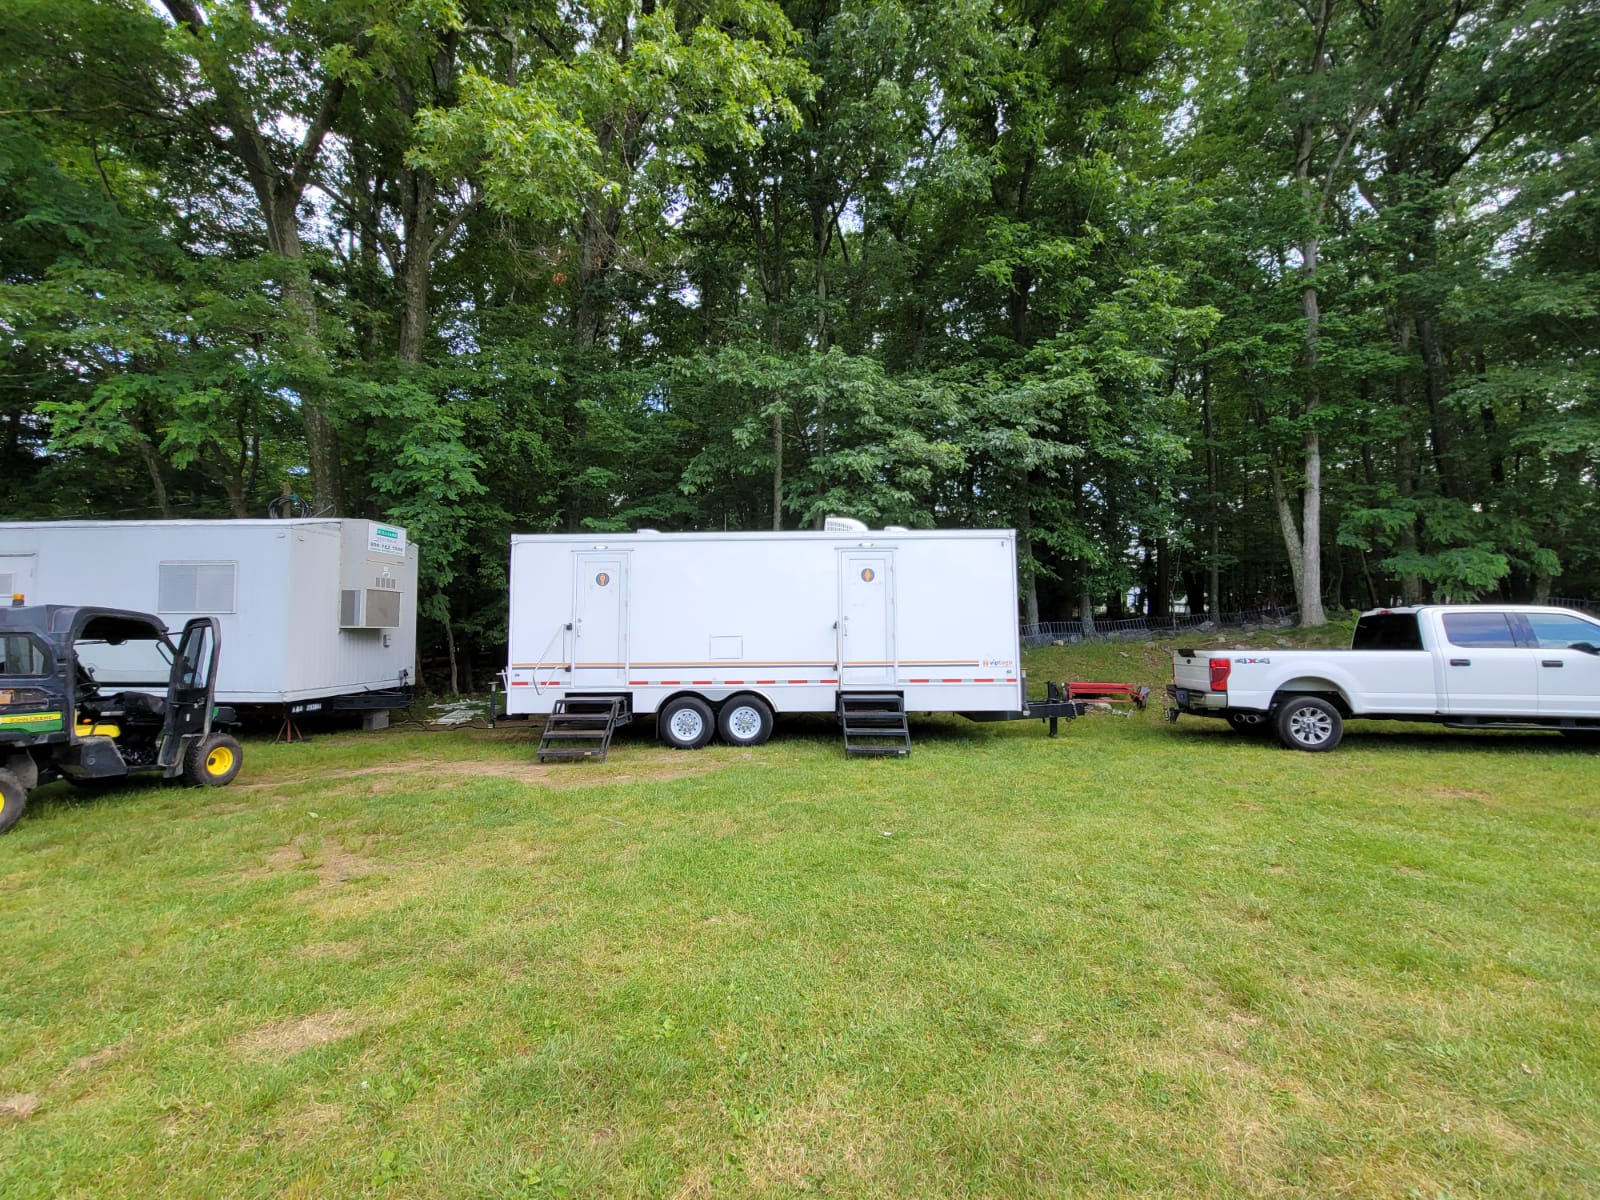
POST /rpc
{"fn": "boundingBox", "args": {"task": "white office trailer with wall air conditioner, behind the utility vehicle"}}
[0,518,418,715]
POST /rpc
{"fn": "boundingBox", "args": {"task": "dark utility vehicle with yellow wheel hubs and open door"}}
[0,603,243,834]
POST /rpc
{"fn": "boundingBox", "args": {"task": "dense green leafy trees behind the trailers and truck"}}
[0,0,1600,686]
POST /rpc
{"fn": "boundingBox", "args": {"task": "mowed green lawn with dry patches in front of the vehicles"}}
[0,634,1600,1200]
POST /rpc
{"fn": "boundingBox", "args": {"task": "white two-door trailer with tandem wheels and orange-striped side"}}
[506,522,1045,752]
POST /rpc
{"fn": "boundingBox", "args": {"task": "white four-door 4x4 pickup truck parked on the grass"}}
[1166,605,1600,750]
